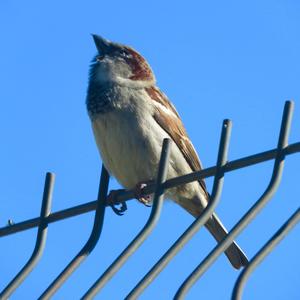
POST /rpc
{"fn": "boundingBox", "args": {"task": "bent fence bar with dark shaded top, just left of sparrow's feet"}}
[39,166,109,299]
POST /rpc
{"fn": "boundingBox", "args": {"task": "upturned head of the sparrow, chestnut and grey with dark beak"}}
[91,35,155,88]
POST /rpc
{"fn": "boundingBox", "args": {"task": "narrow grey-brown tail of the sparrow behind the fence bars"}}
[205,214,248,269]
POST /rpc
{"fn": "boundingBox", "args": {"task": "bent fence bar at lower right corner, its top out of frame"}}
[231,208,300,300]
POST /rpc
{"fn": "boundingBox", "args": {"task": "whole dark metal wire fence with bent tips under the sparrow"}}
[0,101,300,299]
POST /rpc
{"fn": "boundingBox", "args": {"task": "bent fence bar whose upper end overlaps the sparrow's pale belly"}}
[82,139,171,299]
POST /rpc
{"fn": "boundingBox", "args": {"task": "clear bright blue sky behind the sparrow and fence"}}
[0,0,300,300]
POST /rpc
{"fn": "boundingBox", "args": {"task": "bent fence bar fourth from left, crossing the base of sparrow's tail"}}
[126,120,232,300]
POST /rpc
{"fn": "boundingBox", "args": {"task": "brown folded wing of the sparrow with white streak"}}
[146,87,208,196]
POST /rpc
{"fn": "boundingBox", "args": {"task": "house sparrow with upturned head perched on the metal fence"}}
[86,35,248,269]
